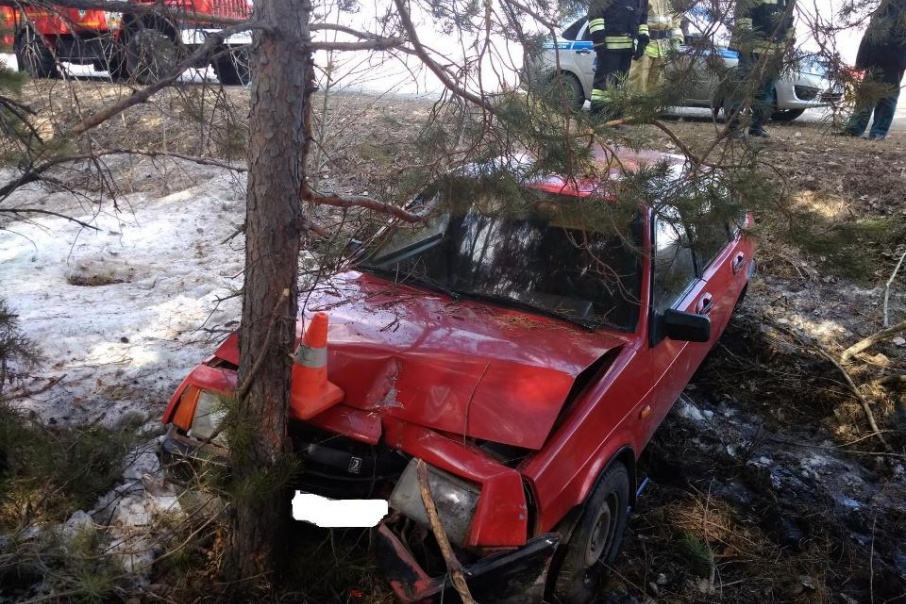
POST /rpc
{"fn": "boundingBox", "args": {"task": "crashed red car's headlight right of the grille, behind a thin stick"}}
[390,459,481,546]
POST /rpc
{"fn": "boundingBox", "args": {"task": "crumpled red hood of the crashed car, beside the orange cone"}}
[216,272,624,449]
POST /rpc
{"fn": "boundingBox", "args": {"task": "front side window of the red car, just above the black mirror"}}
[651,208,697,312]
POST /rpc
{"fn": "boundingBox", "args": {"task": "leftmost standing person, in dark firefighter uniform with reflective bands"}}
[588,0,648,118]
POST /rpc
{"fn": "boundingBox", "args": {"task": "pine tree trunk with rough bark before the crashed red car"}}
[224,0,312,589]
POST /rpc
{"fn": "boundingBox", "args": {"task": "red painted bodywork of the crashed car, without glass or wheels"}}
[163,147,754,588]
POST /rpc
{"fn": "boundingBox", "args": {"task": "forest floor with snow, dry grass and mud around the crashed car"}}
[0,76,906,604]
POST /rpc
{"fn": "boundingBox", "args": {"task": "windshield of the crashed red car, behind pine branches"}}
[358,179,641,331]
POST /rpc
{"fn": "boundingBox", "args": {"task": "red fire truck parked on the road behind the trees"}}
[0,0,252,85]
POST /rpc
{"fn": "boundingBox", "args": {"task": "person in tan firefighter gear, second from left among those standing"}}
[629,0,683,94]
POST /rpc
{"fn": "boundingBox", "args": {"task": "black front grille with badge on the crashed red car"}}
[289,422,409,499]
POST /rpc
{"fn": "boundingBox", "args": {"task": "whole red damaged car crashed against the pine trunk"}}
[163,151,755,603]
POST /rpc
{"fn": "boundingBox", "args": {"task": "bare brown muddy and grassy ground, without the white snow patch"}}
[1,76,906,604]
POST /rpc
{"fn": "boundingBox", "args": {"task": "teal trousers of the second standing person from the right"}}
[727,52,781,131]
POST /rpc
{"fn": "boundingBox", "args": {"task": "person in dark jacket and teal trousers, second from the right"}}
[728,0,796,137]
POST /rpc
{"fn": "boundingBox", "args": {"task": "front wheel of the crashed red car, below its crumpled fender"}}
[550,462,629,604]
